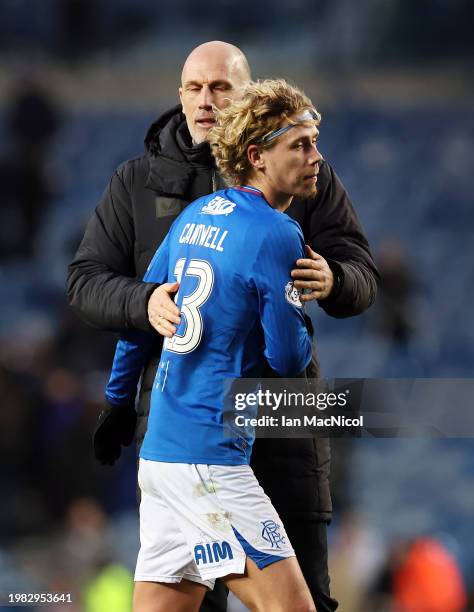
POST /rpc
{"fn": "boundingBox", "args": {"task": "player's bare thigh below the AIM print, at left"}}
[133,580,206,612]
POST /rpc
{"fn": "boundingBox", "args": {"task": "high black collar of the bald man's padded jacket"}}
[145,104,214,197]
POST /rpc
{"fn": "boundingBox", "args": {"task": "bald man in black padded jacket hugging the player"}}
[67,41,378,612]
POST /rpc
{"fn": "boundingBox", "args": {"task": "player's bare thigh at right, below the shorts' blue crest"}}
[223,557,316,612]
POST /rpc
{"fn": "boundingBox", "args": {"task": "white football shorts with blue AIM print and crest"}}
[135,459,295,589]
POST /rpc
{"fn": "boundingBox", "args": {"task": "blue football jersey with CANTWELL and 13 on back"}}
[106,187,311,465]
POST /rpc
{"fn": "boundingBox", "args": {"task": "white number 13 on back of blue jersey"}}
[163,258,214,353]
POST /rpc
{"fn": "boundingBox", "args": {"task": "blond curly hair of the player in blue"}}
[208,79,320,185]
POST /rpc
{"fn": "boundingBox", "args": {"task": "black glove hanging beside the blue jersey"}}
[92,400,137,465]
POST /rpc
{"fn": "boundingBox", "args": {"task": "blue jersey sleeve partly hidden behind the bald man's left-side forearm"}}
[105,233,169,405]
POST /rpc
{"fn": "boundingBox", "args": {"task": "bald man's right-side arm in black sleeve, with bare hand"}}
[292,162,379,318]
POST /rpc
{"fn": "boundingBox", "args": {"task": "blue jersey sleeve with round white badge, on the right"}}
[252,217,312,376]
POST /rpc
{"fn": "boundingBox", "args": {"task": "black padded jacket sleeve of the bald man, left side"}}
[67,165,171,331]
